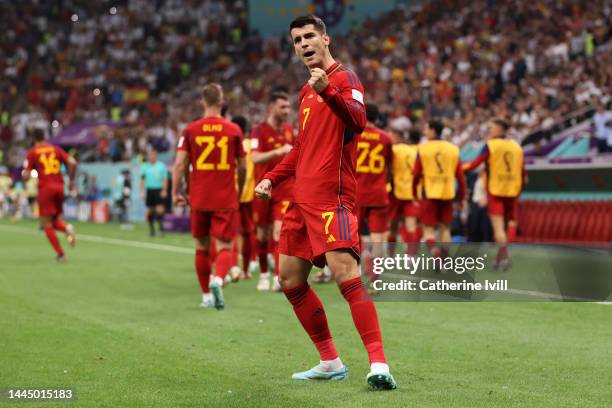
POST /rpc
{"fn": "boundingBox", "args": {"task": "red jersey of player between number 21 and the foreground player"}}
[251,122,294,200]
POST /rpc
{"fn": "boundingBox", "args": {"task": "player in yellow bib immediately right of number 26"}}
[391,129,421,255]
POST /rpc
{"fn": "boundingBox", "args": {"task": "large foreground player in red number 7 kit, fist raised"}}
[255,15,396,389]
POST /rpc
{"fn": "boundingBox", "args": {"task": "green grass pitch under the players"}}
[0,221,612,408]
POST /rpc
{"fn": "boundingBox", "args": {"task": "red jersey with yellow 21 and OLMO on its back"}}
[177,117,245,210]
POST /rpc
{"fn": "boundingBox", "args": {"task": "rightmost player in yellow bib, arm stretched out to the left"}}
[463,118,525,271]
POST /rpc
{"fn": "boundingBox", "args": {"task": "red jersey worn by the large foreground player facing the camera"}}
[265,63,366,210]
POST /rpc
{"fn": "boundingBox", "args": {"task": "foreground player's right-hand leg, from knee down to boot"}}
[325,250,397,390]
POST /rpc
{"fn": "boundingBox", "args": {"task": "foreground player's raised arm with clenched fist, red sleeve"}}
[308,68,367,133]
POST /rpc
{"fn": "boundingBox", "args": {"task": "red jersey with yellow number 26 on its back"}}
[357,127,393,207]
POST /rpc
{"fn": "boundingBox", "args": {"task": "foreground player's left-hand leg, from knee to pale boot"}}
[279,254,348,380]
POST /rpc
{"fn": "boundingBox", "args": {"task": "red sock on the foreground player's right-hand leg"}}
[340,277,387,364]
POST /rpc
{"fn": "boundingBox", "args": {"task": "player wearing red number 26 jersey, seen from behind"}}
[356,103,392,280]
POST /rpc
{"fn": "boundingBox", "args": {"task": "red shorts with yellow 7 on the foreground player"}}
[278,203,359,267]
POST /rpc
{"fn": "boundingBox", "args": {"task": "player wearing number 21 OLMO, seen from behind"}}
[172,83,246,310]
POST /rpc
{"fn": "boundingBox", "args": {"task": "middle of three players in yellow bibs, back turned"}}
[412,120,465,250]
